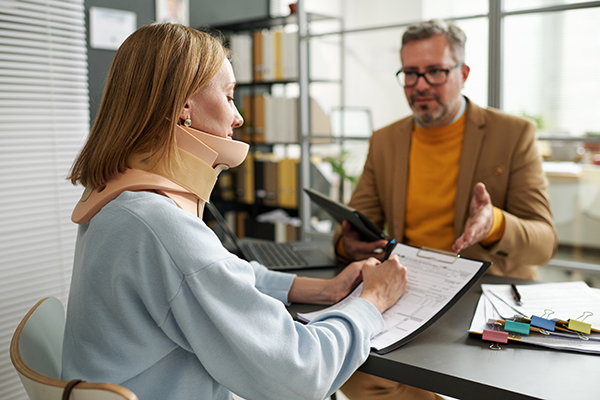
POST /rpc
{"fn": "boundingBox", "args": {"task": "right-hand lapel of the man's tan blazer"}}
[454,100,485,237]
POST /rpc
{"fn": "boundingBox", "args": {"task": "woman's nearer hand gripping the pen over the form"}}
[360,254,408,313]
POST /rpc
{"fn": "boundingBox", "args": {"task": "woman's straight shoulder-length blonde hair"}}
[67,23,228,188]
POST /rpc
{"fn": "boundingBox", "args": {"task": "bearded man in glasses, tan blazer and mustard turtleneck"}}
[334,21,556,400]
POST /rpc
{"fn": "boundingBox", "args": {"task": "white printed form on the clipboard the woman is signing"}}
[298,244,484,350]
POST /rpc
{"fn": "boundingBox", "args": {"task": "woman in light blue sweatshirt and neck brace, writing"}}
[62,23,406,400]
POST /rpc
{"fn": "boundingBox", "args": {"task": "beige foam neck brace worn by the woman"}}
[71,126,249,224]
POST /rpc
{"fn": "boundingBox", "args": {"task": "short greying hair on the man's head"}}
[402,19,467,63]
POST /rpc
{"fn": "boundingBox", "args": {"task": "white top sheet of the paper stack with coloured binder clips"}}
[481,282,600,329]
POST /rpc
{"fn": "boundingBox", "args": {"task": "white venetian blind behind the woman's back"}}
[0,0,89,400]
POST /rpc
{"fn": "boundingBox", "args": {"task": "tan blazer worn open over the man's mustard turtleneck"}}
[334,101,557,279]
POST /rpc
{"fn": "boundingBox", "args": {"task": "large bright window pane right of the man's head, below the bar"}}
[503,8,600,136]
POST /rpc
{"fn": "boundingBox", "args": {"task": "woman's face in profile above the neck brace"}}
[180,60,244,139]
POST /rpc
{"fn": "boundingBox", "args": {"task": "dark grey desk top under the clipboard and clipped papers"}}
[290,269,600,400]
